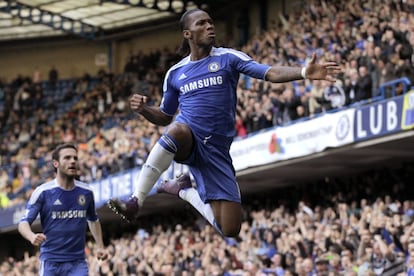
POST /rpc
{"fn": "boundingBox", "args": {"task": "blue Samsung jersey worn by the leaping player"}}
[160,47,270,137]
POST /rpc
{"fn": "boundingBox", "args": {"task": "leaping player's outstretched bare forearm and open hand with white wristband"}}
[265,53,341,82]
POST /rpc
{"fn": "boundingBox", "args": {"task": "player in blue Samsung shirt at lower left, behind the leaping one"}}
[18,144,107,276]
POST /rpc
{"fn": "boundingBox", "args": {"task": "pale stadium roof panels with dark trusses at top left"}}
[0,0,213,41]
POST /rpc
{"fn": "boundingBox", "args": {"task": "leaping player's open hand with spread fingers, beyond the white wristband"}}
[306,53,341,83]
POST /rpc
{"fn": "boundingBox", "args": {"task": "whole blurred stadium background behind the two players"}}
[0,0,414,275]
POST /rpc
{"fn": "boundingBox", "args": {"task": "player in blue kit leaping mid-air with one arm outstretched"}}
[109,9,340,237]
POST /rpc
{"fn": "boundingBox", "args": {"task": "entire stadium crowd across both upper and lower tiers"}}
[0,0,414,275]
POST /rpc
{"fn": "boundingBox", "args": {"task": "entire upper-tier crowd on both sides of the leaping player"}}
[0,0,414,208]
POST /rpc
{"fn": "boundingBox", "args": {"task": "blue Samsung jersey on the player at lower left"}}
[21,179,98,262]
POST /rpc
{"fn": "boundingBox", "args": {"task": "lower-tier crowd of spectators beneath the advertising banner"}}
[0,163,414,276]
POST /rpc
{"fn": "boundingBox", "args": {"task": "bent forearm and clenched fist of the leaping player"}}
[129,94,173,126]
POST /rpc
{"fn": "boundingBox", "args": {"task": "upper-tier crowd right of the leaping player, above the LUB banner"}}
[237,0,414,136]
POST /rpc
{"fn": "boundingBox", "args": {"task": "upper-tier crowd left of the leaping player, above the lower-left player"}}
[0,56,176,208]
